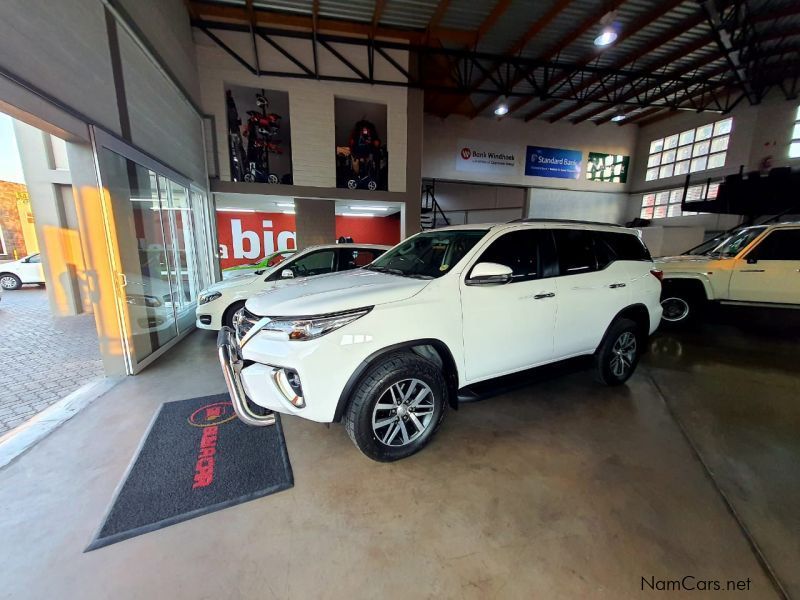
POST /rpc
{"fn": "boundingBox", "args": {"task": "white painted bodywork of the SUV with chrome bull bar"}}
[233,223,661,422]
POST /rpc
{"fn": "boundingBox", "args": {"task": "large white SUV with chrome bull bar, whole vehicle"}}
[218,221,661,461]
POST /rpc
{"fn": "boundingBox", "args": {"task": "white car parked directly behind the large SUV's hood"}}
[197,244,390,330]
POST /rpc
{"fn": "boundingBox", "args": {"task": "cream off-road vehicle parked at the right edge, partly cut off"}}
[656,223,800,325]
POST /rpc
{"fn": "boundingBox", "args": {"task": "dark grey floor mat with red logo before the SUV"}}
[85,394,294,552]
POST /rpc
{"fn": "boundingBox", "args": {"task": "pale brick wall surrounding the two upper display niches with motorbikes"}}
[195,31,408,192]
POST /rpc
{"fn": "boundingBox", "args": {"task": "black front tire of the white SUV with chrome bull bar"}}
[344,352,447,462]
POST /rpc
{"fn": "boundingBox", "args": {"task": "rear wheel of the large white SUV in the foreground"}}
[594,318,645,385]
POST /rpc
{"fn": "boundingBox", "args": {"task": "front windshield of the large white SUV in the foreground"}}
[364,229,487,279]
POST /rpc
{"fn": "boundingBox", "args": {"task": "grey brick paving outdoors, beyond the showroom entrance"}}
[0,286,103,434]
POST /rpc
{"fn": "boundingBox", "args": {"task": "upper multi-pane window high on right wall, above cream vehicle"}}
[644,117,736,181]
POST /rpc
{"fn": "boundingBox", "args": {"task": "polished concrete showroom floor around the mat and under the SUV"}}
[0,310,800,599]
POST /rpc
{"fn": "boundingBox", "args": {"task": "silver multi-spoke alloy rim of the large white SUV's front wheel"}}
[372,379,435,447]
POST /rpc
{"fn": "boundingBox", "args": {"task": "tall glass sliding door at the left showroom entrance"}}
[93,130,208,374]
